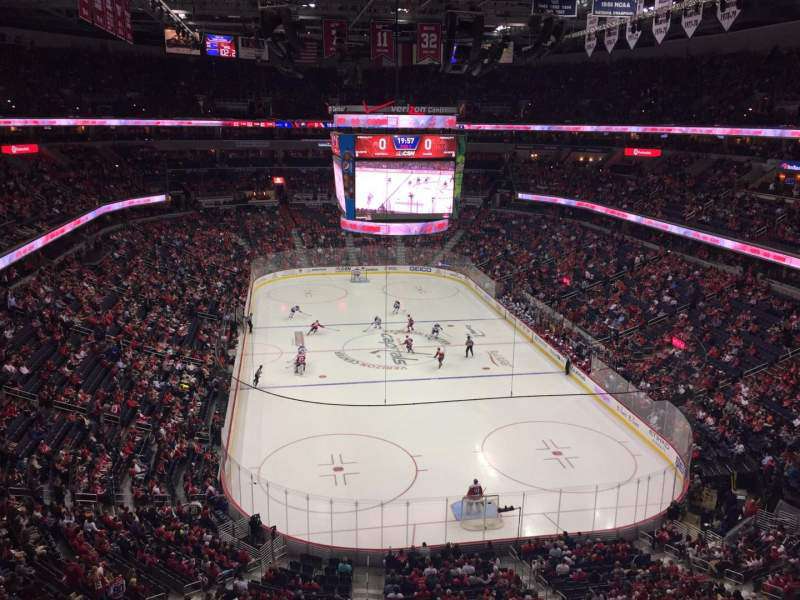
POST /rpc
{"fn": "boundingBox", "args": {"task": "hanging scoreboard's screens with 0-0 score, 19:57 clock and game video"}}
[331,133,464,222]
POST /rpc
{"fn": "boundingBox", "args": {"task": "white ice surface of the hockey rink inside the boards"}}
[225,272,683,548]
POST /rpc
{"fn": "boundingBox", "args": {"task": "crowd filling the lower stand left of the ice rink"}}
[0,209,298,598]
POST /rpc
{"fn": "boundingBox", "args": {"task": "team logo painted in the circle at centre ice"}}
[333,329,450,371]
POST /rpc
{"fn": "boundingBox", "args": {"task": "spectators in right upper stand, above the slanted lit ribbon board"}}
[513,153,800,252]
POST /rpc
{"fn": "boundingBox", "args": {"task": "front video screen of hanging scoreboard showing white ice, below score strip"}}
[355,160,455,219]
